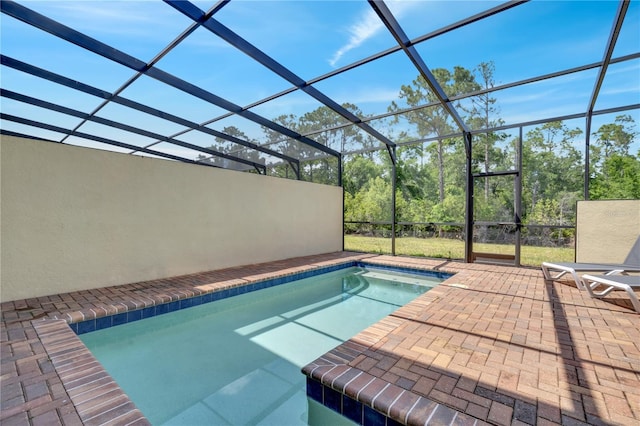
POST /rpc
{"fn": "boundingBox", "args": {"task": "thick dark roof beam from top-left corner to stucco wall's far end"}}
[0,0,339,157]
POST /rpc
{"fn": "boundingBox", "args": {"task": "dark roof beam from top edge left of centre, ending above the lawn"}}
[164,0,395,146]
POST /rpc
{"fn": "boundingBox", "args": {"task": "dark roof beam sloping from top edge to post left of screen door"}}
[369,0,470,143]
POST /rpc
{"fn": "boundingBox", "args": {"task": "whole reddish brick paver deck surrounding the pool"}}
[0,252,640,425]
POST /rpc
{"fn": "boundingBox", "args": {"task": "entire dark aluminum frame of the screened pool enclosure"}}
[0,0,640,263]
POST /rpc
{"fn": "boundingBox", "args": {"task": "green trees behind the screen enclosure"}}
[200,62,640,243]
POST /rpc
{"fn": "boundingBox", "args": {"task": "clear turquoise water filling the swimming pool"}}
[80,267,442,425]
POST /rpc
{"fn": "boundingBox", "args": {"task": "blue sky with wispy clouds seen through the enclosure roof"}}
[1,0,640,161]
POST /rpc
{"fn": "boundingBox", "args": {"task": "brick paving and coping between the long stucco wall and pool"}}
[0,252,370,425]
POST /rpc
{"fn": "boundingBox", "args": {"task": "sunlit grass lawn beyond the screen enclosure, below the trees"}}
[344,235,574,266]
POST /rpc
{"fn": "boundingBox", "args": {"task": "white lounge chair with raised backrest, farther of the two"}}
[542,236,640,289]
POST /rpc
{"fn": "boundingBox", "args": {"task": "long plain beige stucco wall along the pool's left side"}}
[0,136,342,301]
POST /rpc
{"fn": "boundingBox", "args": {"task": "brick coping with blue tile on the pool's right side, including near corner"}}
[301,270,476,426]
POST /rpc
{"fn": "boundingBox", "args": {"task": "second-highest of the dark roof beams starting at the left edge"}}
[0,55,299,170]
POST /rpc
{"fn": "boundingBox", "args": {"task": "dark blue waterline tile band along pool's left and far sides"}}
[69,260,453,335]
